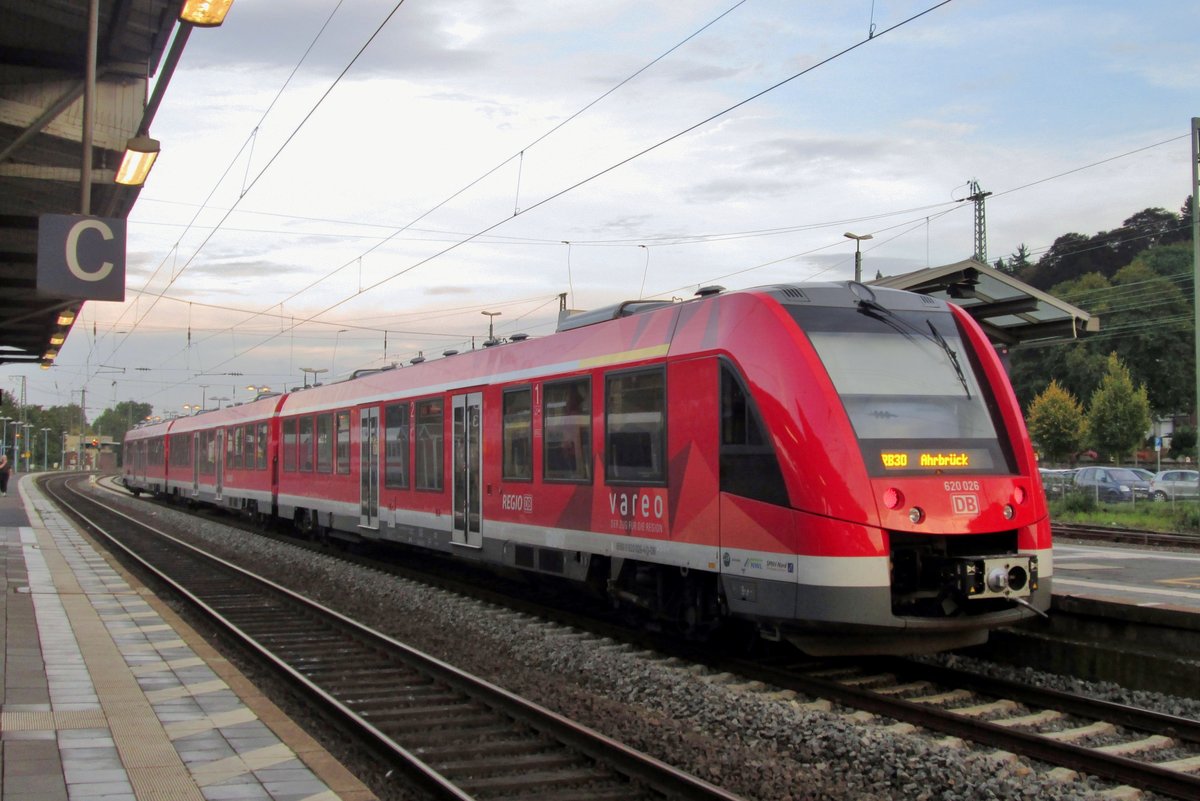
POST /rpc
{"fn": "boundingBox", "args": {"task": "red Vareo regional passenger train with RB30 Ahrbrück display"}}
[125,282,1051,654]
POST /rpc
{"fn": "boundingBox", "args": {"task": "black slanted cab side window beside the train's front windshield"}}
[720,365,788,506]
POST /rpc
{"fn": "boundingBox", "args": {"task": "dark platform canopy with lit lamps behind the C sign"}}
[0,0,186,363]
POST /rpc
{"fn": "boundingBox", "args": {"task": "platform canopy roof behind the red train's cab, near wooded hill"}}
[869,259,1100,347]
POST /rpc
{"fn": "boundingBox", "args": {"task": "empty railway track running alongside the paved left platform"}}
[44,477,738,801]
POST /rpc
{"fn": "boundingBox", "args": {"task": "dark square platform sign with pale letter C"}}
[37,215,125,301]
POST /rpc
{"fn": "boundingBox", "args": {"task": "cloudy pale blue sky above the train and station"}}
[0,0,1200,418]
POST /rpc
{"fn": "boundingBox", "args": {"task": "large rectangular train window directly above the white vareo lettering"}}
[605,368,667,483]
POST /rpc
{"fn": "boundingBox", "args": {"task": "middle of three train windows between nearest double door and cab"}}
[541,378,592,481]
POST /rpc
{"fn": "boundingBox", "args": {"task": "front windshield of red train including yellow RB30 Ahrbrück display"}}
[790,303,1013,475]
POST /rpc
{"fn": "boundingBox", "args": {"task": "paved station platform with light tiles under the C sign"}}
[0,476,376,801]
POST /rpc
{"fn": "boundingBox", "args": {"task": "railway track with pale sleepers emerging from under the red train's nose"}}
[726,658,1200,800]
